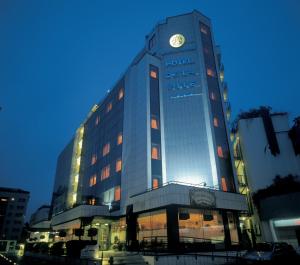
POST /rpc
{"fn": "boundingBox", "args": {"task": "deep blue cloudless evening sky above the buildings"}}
[0,0,300,217]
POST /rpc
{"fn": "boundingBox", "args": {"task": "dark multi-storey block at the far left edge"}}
[0,187,29,240]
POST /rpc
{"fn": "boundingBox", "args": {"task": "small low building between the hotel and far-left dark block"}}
[29,205,52,242]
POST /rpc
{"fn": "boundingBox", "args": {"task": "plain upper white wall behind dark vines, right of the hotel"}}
[238,112,300,192]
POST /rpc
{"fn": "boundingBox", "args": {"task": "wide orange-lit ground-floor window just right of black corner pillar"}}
[178,208,224,243]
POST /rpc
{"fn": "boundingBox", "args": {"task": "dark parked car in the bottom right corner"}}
[242,242,299,265]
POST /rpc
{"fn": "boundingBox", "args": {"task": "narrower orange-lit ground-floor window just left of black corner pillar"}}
[137,210,167,242]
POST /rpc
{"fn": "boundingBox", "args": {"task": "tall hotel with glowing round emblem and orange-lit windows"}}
[51,11,247,248]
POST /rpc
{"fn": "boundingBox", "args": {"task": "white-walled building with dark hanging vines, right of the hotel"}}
[234,107,300,246]
